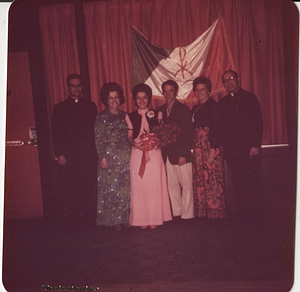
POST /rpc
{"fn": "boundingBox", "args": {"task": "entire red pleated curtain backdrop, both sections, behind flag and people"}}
[41,0,296,144]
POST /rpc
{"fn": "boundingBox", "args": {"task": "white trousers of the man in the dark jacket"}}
[166,158,194,219]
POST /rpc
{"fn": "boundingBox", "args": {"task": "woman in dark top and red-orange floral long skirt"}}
[192,76,226,218]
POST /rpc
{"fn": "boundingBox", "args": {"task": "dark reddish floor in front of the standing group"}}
[3,194,294,292]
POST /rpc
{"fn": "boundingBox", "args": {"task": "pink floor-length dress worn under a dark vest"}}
[126,109,172,226]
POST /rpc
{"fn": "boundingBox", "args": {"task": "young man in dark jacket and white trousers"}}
[158,80,194,219]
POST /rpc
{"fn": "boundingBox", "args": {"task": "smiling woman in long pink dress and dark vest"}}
[126,84,172,229]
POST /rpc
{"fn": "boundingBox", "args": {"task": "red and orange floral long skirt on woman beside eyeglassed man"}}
[193,127,226,218]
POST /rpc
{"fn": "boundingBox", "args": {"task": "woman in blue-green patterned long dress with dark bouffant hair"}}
[95,82,130,230]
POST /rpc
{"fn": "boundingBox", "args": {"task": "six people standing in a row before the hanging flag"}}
[52,70,263,230]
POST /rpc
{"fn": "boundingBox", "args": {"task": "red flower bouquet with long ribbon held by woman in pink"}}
[139,122,180,178]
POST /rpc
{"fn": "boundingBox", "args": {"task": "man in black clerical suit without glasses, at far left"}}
[52,74,98,224]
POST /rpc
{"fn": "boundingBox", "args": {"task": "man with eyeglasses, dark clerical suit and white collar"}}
[219,70,263,217]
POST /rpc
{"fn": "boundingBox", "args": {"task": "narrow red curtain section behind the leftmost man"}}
[39,4,80,109]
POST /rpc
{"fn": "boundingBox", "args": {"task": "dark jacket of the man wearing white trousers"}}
[157,100,193,165]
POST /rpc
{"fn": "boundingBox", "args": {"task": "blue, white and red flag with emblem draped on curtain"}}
[130,17,234,99]
